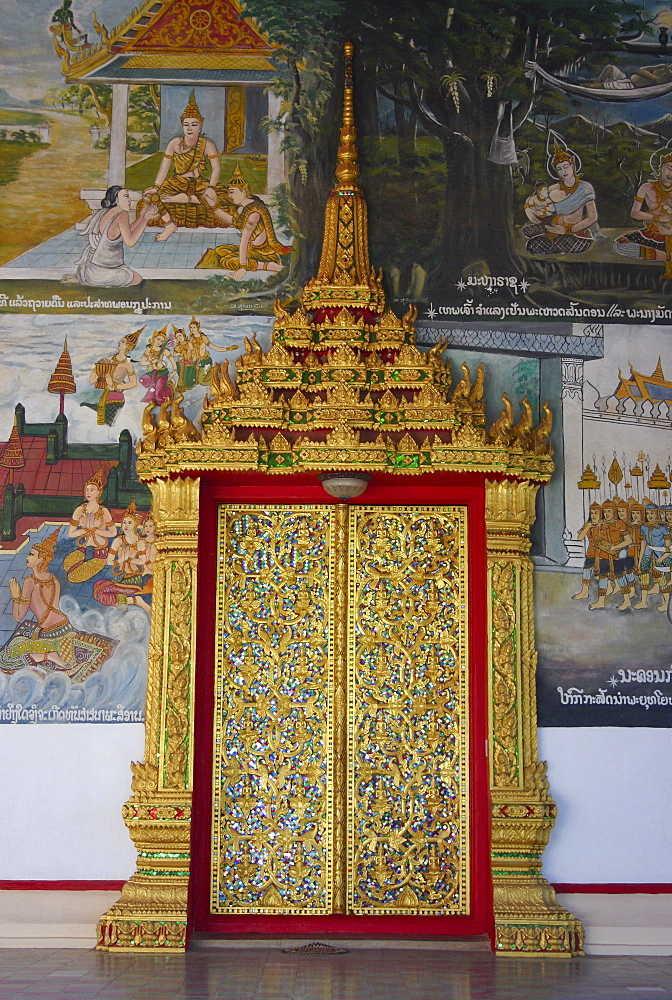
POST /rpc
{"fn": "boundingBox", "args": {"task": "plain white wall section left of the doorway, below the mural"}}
[0,724,145,880]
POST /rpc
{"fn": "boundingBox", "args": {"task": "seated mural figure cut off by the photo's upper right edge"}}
[614,150,672,260]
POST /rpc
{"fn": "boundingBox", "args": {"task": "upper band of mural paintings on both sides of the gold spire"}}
[0,0,672,323]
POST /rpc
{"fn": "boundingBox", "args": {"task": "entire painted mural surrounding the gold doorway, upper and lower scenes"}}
[0,0,672,726]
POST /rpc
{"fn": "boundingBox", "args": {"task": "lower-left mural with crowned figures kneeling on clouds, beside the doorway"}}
[0,316,268,723]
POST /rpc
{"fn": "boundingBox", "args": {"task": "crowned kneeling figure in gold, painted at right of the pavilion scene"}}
[196,164,292,280]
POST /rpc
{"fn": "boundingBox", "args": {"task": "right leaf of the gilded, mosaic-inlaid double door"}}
[348,507,469,914]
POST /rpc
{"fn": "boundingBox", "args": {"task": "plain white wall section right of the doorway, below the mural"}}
[539,727,672,883]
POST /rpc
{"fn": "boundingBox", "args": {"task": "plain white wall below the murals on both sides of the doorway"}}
[0,725,672,883]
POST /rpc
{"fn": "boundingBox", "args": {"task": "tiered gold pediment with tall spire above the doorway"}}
[137,43,553,482]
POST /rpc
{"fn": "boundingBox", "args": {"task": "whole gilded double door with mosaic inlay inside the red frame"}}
[210,504,470,915]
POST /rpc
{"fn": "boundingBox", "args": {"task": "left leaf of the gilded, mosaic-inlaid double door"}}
[211,505,334,914]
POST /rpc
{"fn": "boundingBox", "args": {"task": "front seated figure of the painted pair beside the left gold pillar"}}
[93,500,151,611]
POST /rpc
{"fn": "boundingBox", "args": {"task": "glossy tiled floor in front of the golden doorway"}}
[0,947,672,1000]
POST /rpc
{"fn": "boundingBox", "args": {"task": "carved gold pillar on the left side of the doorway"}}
[98,478,200,951]
